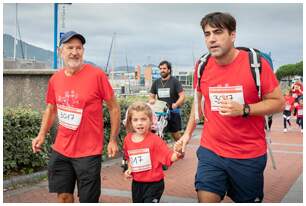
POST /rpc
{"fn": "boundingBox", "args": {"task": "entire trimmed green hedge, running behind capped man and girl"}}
[3,97,192,178]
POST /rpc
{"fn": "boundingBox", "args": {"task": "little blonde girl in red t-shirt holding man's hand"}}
[123,102,183,203]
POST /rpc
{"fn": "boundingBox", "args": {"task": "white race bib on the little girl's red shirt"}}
[128,148,152,172]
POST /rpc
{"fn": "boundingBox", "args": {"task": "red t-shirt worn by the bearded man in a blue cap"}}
[46,64,114,158]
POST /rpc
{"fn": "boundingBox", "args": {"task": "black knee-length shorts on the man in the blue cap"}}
[48,151,101,202]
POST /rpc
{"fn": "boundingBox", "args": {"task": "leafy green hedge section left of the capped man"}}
[3,108,51,176]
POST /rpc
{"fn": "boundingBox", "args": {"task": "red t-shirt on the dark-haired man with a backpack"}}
[194,51,278,159]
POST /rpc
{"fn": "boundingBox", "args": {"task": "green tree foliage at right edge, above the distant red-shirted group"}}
[276,61,303,80]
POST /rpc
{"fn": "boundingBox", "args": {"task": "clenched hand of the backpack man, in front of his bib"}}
[219,100,243,117]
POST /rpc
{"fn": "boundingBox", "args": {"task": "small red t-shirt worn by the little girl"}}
[123,132,173,182]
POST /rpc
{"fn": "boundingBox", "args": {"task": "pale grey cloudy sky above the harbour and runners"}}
[3,3,303,70]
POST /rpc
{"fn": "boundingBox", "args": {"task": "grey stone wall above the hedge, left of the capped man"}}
[3,69,56,111]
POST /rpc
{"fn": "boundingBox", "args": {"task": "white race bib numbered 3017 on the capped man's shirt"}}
[57,105,83,130]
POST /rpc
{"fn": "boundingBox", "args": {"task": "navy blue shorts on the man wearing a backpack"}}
[195,146,267,202]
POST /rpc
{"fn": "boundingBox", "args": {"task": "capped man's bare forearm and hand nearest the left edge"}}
[32,104,57,153]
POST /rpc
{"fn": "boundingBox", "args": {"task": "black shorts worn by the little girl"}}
[132,179,165,203]
